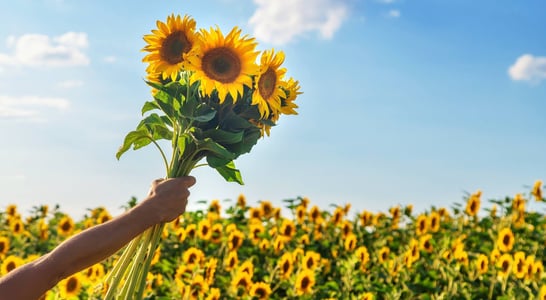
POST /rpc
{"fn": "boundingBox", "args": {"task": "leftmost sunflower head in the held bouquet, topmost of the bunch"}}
[142,14,196,81]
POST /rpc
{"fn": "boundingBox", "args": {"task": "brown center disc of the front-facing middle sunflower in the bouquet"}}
[202,47,241,83]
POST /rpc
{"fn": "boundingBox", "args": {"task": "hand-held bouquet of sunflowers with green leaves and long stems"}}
[100,15,301,299]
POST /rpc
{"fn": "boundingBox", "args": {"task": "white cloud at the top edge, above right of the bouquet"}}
[249,0,349,45]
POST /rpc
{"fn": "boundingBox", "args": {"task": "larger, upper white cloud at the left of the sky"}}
[0,32,89,67]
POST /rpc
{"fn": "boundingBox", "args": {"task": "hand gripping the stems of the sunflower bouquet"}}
[142,176,195,222]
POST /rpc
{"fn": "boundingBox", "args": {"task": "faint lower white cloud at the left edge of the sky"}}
[0,95,70,119]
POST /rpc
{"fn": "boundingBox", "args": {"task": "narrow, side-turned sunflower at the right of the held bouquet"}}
[252,50,286,118]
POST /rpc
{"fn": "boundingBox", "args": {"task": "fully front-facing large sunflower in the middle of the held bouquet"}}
[185,27,258,103]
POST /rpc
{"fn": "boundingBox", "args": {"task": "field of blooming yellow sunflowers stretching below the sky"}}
[0,181,546,299]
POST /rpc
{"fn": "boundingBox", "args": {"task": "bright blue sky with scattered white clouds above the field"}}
[0,0,546,216]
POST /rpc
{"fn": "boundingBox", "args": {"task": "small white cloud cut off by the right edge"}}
[508,54,546,83]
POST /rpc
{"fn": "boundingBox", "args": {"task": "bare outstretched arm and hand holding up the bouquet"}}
[0,176,195,300]
